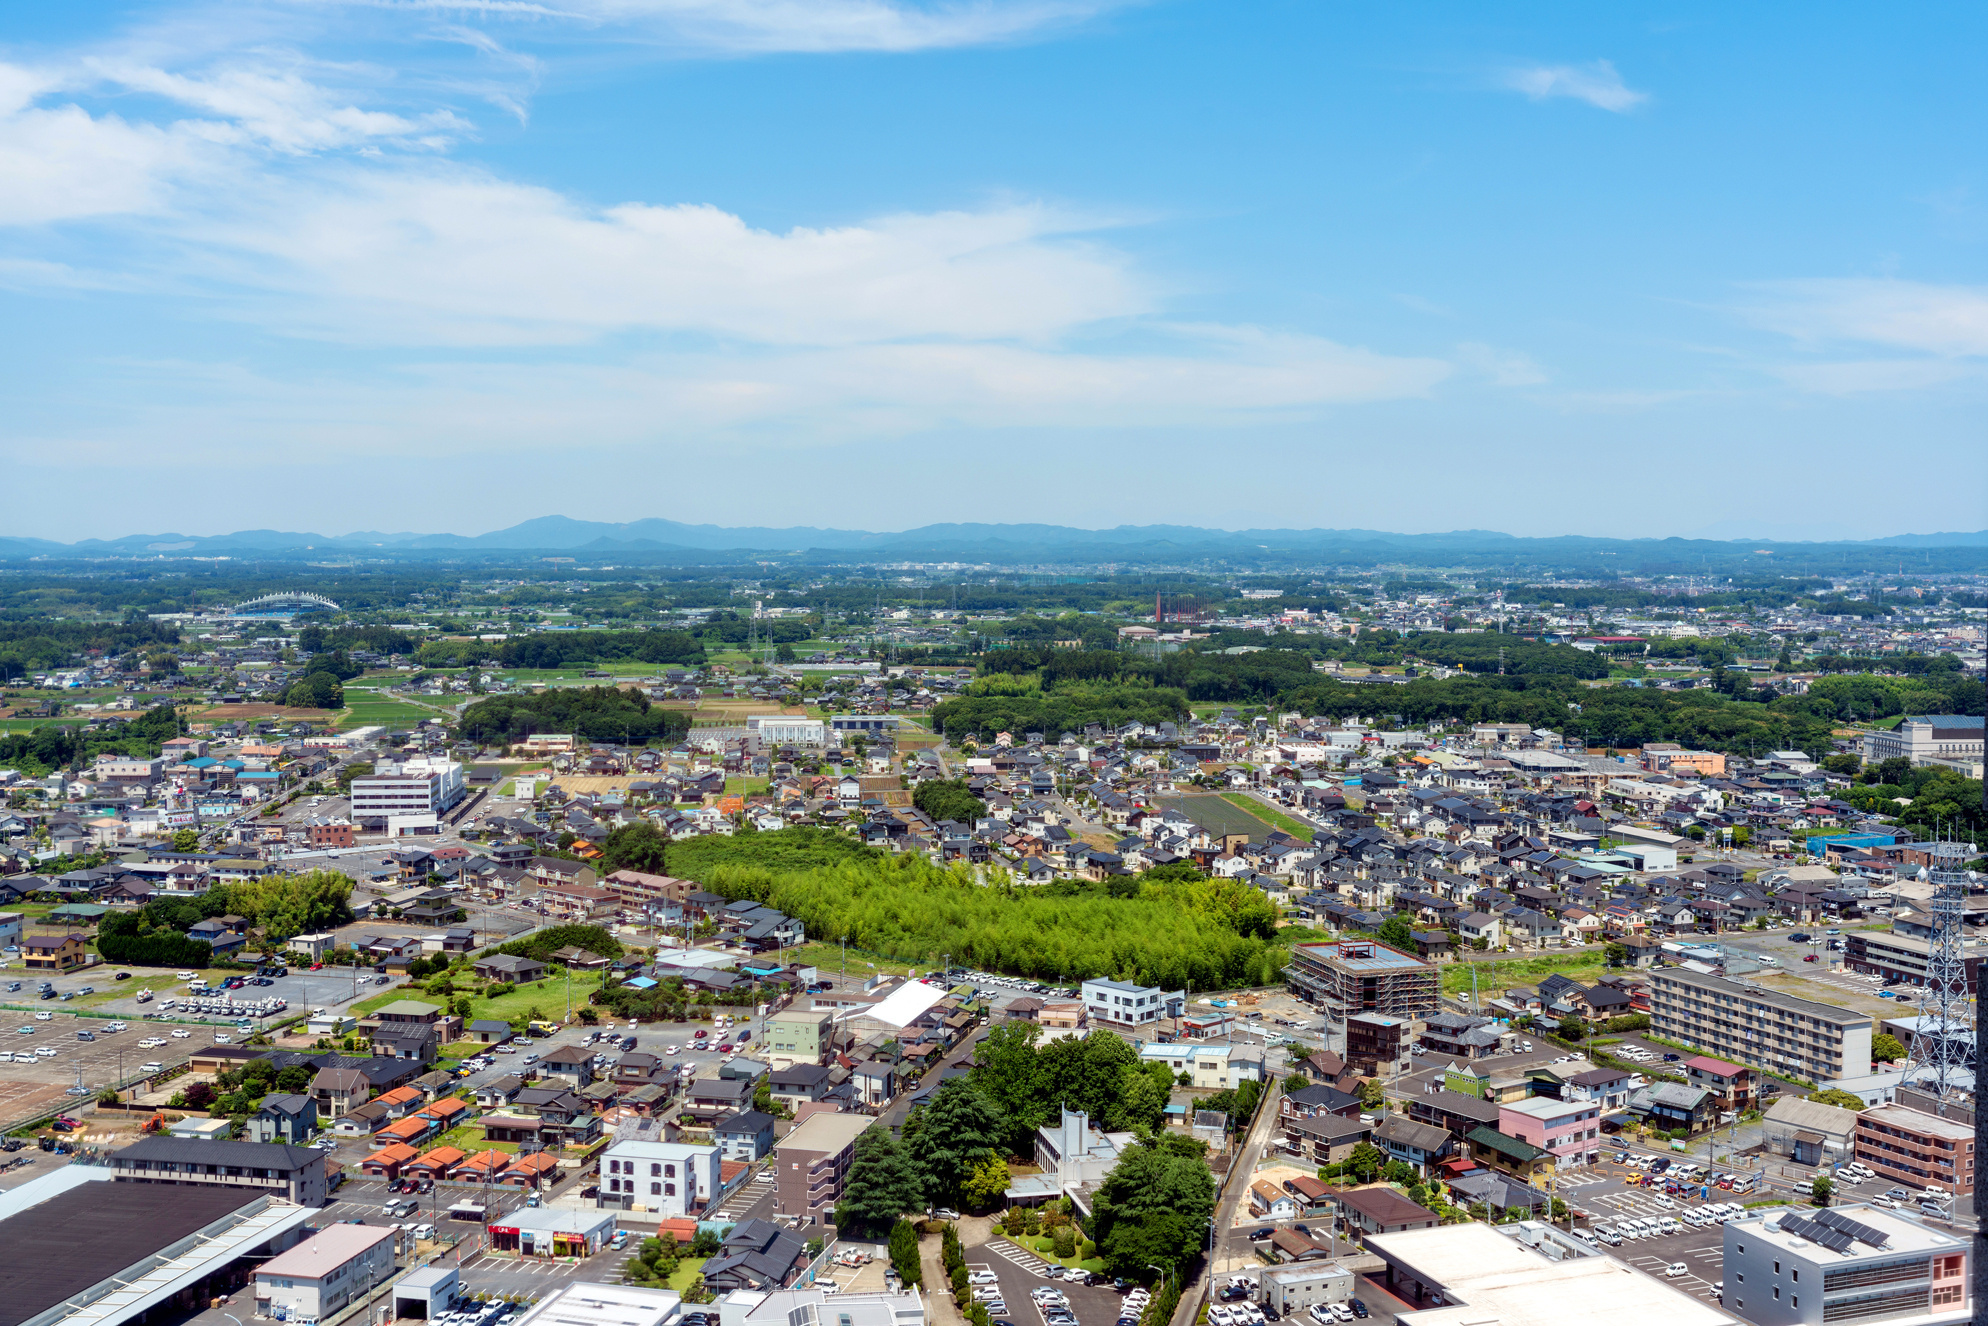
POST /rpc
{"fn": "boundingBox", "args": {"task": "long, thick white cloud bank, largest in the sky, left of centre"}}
[193,165,1155,344]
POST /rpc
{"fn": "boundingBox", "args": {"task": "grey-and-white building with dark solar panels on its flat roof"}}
[1725,1205,1974,1326]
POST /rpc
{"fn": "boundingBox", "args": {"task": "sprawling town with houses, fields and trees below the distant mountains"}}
[0,557,1988,1326]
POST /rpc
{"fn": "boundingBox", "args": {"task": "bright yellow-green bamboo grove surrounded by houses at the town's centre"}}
[687,829,1284,990]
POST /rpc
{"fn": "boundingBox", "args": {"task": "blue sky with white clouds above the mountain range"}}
[0,0,1988,539]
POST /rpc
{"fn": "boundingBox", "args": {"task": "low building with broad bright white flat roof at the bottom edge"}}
[1366,1221,1743,1326]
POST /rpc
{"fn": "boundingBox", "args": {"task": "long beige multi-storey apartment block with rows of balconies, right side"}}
[1650,968,1871,1081]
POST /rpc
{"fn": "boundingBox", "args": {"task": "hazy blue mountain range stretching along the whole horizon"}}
[0,515,1988,571]
